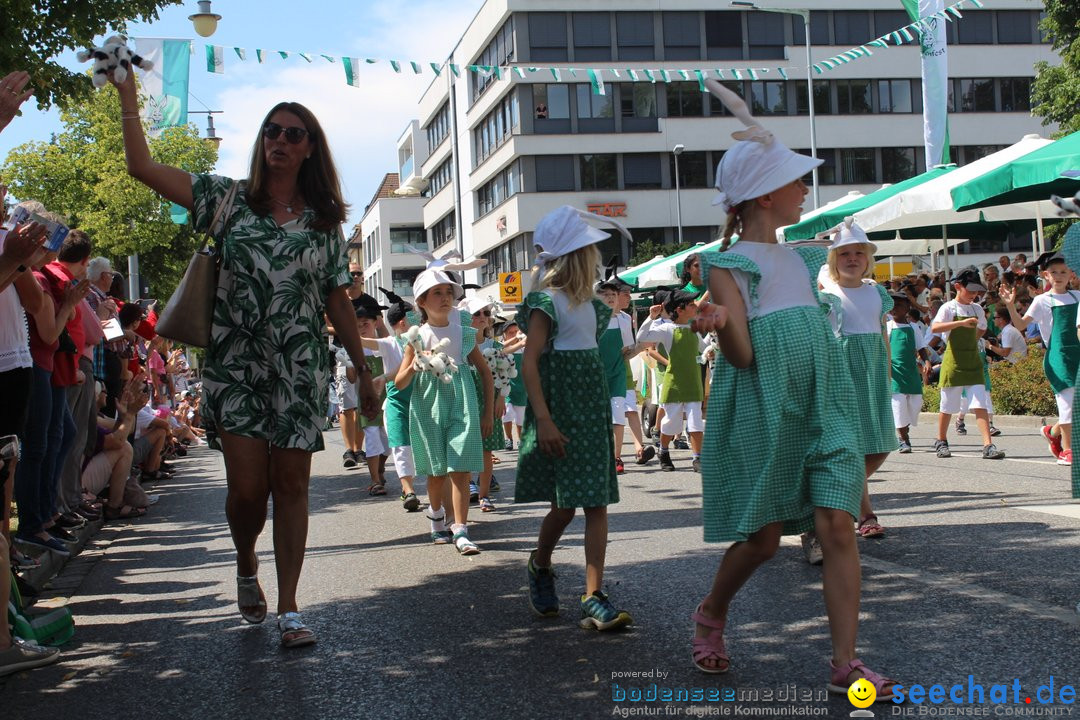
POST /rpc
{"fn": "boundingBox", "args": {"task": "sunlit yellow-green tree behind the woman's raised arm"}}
[0,77,217,298]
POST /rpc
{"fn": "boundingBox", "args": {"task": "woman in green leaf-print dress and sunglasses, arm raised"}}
[116,69,378,648]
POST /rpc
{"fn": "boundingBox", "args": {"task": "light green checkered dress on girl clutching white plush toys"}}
[408,312,484,477]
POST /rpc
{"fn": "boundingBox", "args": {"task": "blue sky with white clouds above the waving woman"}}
[0,0,483,225]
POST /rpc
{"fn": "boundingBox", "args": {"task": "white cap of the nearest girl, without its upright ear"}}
[713,138,825,213]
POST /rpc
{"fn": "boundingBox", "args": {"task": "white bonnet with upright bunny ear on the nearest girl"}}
[705,79,825,214]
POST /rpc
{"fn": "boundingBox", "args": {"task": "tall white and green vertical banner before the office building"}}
[902,0,949,167]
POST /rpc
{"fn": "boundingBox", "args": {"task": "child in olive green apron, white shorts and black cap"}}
[930,268,1005,460]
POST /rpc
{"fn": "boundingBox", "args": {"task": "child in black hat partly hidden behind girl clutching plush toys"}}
[363,288,420,513]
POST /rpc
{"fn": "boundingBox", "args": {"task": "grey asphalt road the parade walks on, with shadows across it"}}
[0,418,1080,720]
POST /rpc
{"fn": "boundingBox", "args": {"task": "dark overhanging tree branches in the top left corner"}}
[0,0,181,108]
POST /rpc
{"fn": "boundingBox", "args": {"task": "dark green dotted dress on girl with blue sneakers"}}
[514,290,619,507]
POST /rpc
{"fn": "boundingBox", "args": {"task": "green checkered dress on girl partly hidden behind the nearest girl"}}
[822,284,900,456]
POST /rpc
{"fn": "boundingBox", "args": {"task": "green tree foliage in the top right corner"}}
[1031,0,1080,136]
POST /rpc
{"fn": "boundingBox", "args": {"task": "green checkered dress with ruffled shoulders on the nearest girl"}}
[701,247,864,542]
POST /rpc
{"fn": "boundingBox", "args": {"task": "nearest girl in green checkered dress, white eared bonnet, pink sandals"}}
[692,80,895,702]
